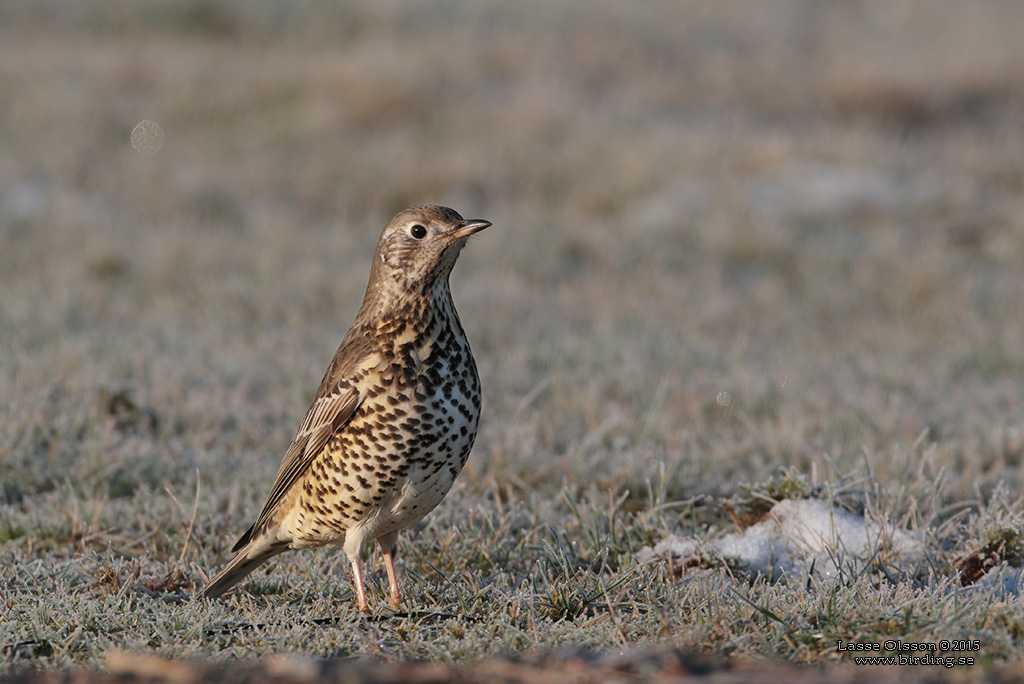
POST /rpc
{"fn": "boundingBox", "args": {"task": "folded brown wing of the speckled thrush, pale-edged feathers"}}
[231,333,380,552]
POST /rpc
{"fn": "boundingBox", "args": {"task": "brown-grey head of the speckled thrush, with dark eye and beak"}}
[365,205,490,311]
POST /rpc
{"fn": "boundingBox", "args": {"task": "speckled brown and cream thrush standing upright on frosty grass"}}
[199,205,492,613]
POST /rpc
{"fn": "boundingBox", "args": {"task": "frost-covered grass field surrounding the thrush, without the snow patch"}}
[0,0,1024,681]
